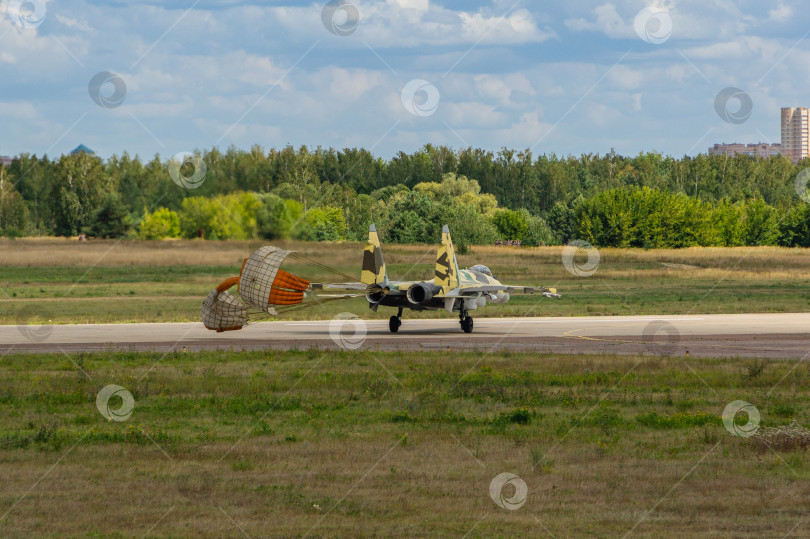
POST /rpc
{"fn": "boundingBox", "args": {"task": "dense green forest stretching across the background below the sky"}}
[0,145,810,248]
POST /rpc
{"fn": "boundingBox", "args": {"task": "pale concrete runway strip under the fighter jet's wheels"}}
[0,313,810,359]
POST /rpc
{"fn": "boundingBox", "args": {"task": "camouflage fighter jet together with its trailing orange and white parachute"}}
[201,225,560,333]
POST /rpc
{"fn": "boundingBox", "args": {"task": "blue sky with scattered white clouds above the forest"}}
[0,0,810,159]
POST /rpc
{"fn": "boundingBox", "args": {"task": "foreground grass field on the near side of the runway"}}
[0,351,810,537]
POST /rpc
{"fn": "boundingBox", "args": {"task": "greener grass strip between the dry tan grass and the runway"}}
[0,266,810,324]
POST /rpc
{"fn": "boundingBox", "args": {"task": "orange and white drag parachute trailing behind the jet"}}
[202,246,357,332]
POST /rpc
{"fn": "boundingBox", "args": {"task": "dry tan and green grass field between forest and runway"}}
[0,239,810,324]
